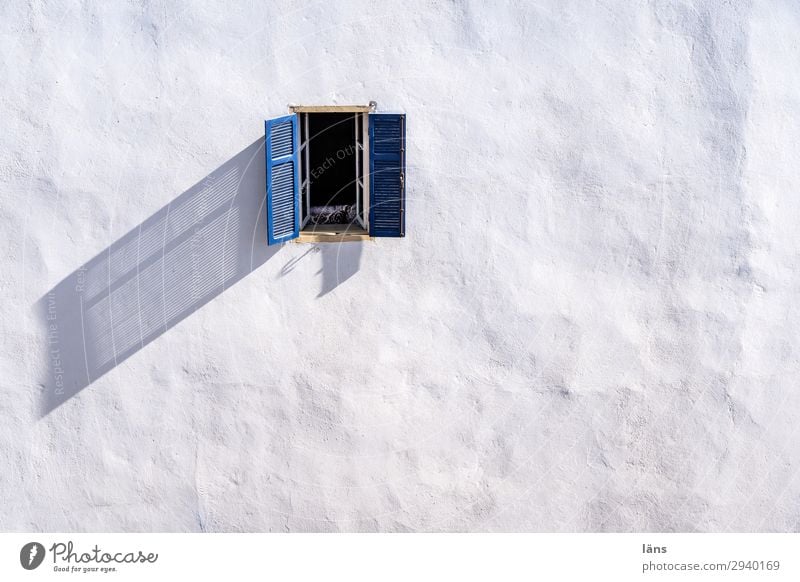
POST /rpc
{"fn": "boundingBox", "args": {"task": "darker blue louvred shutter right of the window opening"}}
[369,113,406,236]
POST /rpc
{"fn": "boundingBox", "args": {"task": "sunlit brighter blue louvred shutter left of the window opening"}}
[264,114,300,245]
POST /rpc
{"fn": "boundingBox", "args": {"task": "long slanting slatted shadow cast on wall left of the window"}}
[35,138,280,416]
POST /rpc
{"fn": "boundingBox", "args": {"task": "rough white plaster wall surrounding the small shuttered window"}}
[0,0,800,531]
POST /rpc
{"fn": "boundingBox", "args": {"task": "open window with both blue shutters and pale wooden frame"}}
[265,102,405,245]
